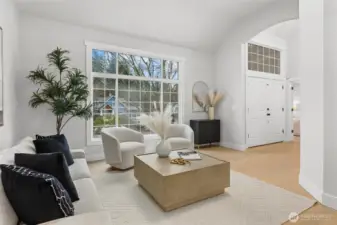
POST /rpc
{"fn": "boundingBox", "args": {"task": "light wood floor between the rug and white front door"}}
[201,139,337,225]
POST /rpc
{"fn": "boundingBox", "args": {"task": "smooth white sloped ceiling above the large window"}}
[16,0,277,51]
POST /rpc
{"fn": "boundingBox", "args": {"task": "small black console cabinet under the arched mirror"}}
[190,120,220,147]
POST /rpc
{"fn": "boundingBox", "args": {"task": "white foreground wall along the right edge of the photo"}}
[300,0,337,209]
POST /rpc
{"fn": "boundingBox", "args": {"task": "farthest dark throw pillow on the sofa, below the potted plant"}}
[33,134,74,166]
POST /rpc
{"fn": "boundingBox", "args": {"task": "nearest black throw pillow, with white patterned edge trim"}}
[0,165,74,225]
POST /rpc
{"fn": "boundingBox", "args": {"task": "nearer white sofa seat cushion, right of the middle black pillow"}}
[74,178,103,215]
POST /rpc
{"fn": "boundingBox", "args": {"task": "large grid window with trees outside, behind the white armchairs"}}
[89,49,180,138]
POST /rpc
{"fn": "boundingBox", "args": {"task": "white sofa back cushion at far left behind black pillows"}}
[0,137,36,165]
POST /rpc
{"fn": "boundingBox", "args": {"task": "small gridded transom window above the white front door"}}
[248,43,281,75]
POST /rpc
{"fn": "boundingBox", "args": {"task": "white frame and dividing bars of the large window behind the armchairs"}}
[85,41,185,146]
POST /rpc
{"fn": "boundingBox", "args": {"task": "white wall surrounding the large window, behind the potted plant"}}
[16,15,215,156]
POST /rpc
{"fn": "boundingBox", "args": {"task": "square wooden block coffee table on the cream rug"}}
[134,152,230,211]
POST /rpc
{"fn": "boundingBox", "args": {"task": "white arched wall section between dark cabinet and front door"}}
[216,0,298,150]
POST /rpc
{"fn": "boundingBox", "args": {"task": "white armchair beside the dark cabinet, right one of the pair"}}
[166,124,194,150]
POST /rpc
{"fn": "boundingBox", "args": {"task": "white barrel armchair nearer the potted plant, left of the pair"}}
[101,127,145,170]
